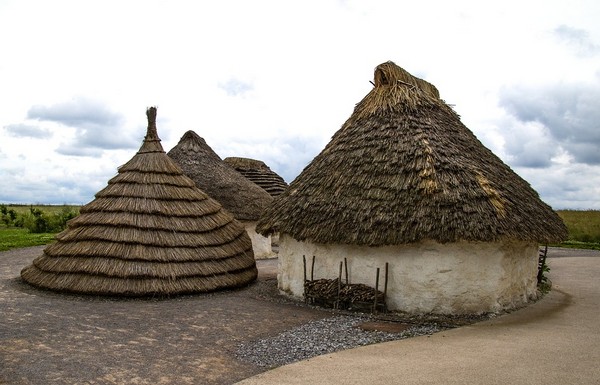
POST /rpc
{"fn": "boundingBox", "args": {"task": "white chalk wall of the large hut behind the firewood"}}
[277,234,538,314]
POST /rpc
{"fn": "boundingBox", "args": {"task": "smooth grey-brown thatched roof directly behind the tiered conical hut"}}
[167,131,273,221]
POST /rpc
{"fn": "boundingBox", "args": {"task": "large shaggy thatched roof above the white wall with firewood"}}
[257,62,567,246]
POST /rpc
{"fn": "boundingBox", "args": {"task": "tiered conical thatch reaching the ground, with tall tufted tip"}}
[21,108,257,296]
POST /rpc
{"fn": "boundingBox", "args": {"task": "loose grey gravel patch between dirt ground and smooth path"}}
[235,316,442,368]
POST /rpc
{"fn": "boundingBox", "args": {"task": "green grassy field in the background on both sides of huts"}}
[0,205,600,251]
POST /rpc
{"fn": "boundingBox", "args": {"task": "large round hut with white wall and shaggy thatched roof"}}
[257,62,567,314]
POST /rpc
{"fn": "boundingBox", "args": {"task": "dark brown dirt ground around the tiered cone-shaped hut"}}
[0,246,596,384]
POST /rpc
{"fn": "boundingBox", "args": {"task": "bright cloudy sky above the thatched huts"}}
[0,0,600,209]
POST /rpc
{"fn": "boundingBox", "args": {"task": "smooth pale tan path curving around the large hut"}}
[239,252,600,385]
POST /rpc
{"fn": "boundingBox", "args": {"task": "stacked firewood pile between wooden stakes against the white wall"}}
[304,278,385,309]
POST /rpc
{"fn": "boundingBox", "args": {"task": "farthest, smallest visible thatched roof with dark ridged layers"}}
[224,157,287,197]
